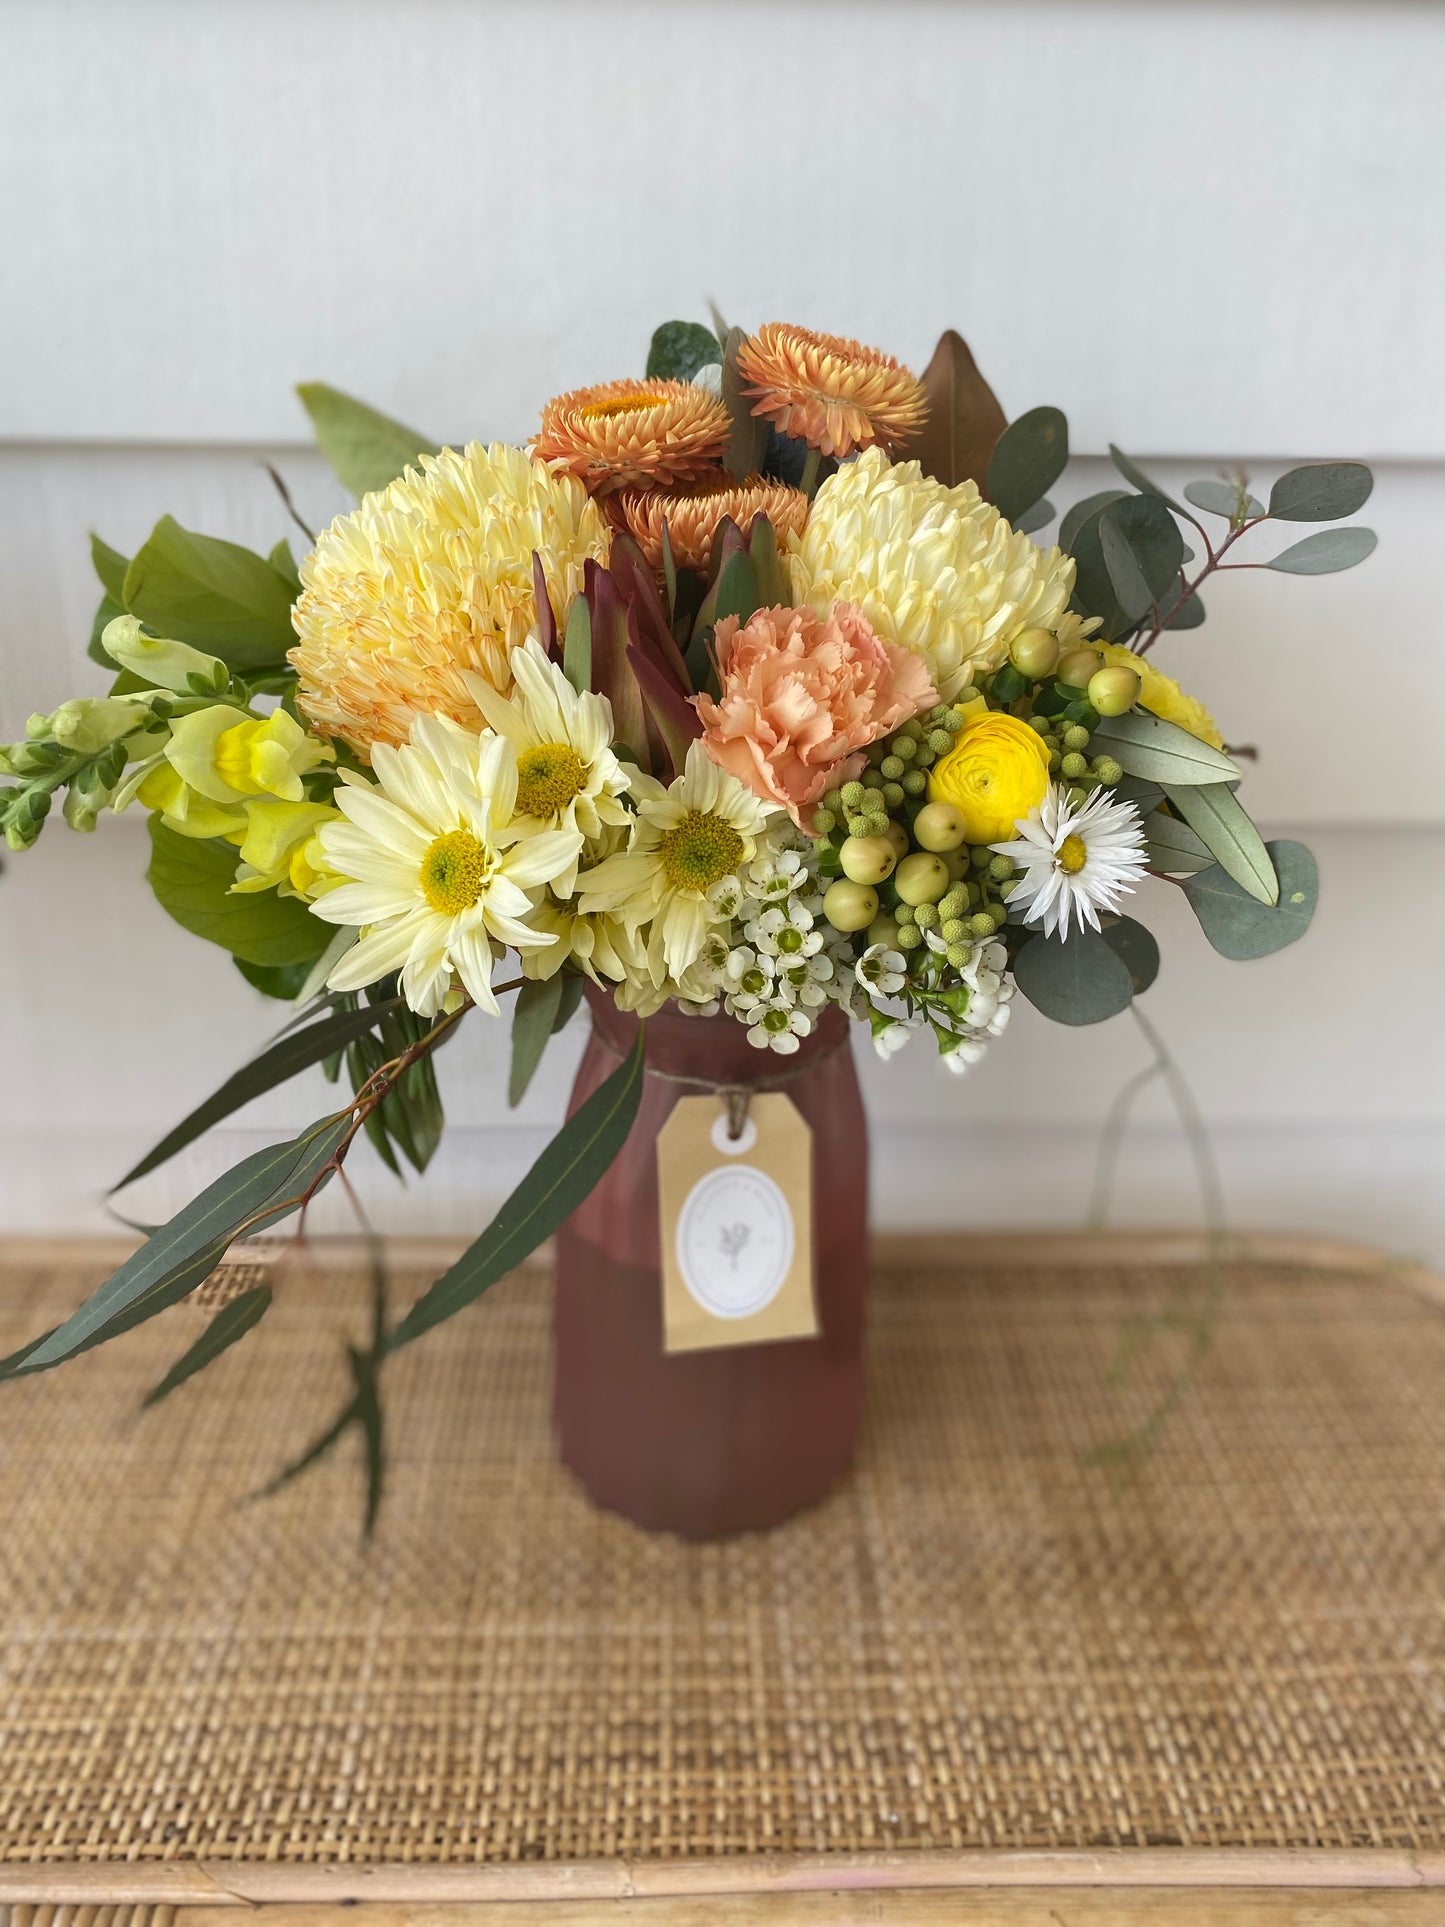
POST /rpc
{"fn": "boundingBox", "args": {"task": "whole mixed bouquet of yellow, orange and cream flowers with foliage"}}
[0,322,1374,1487]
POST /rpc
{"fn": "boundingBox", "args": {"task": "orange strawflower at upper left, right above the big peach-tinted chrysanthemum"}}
[532,382,732,495]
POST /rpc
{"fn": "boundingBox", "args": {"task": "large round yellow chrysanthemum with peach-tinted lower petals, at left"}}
[291,441,611,759]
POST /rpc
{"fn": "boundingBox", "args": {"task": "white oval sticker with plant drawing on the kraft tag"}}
[676,1164,794,1318]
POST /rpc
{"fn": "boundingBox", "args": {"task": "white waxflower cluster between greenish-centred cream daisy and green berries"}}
[686,825,852,1056]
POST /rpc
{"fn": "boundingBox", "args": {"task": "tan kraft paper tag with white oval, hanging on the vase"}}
[657,1091,819,1351]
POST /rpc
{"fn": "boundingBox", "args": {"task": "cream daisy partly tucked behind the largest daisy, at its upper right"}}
[462,636,632,896]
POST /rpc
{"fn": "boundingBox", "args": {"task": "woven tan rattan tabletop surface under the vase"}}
[0,1233,1445,1865]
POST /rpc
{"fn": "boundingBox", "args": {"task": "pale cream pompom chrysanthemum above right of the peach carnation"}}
[788,449,1073,701]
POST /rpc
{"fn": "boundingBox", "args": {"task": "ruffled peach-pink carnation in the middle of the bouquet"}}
[694,601,938,829]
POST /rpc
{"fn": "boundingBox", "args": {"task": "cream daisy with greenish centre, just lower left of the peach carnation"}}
[578,742,776,985]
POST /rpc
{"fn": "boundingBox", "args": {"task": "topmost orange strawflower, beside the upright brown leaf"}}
[738,322,929,455]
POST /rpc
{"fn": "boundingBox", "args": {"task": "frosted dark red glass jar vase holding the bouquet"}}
[553,989,867,1540]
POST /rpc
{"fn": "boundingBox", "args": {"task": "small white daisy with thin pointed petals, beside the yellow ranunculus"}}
[992,782,1148,937]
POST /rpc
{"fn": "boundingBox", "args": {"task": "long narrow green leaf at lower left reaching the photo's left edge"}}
[8,1116,351,1376]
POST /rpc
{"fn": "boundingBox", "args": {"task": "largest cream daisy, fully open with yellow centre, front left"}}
[312,717,582,1017]
